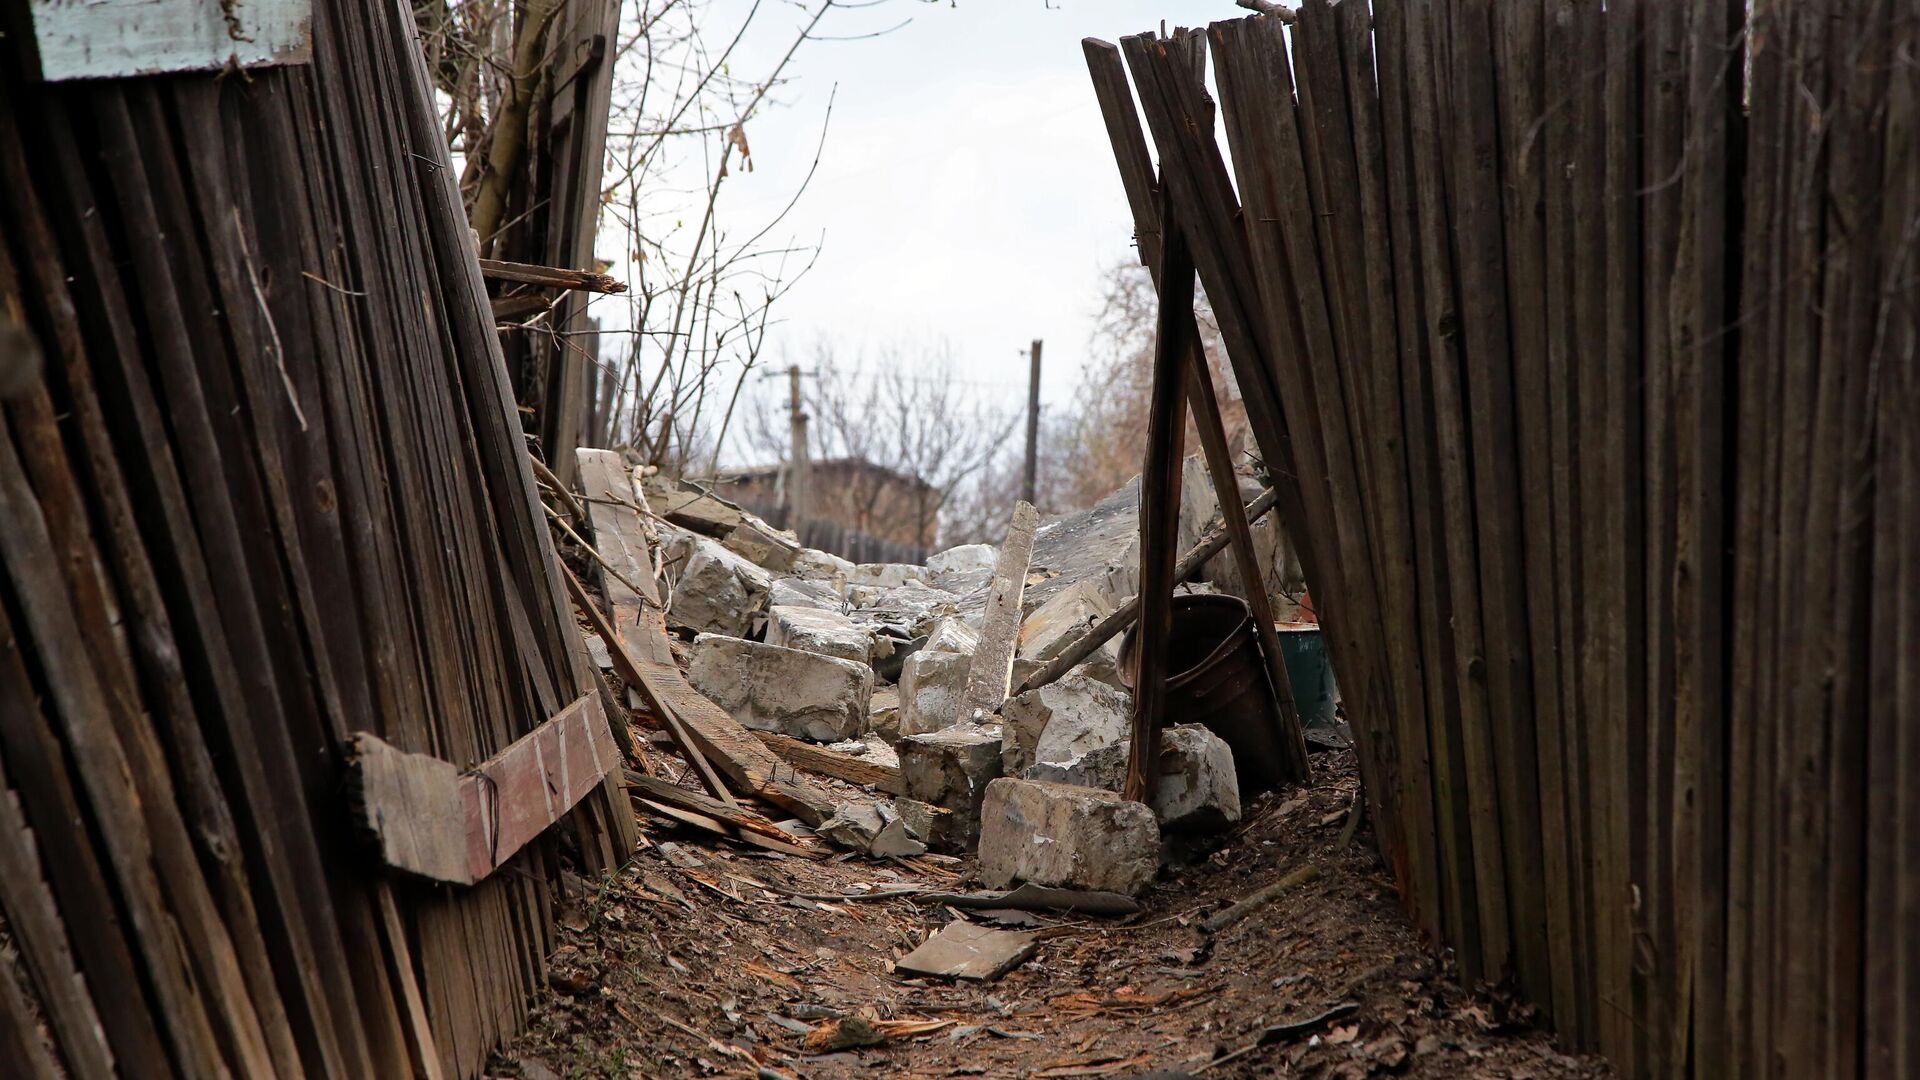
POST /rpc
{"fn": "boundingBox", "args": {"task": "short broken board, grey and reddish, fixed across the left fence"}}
[349,694,620,884]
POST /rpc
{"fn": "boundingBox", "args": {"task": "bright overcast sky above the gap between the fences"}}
[652,0,1244,459]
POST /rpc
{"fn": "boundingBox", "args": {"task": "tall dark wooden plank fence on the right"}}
[1087,0,1920,1076]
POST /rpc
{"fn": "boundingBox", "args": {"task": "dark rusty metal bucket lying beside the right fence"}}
[1119,594,1283,798]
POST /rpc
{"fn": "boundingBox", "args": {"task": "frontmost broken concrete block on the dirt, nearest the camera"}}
[979,776,1160,896]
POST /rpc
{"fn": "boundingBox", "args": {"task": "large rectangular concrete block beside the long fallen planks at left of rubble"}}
[687,634,874,742]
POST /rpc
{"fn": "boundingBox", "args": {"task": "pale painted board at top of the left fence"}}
[29,0,313,83]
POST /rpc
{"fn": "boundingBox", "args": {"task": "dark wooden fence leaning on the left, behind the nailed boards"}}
[0,0,634,1076]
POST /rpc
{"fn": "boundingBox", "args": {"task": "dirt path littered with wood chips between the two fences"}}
[495,753,1605,1080]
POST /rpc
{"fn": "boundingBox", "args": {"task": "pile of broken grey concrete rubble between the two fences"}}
[647,461,1284,894]
